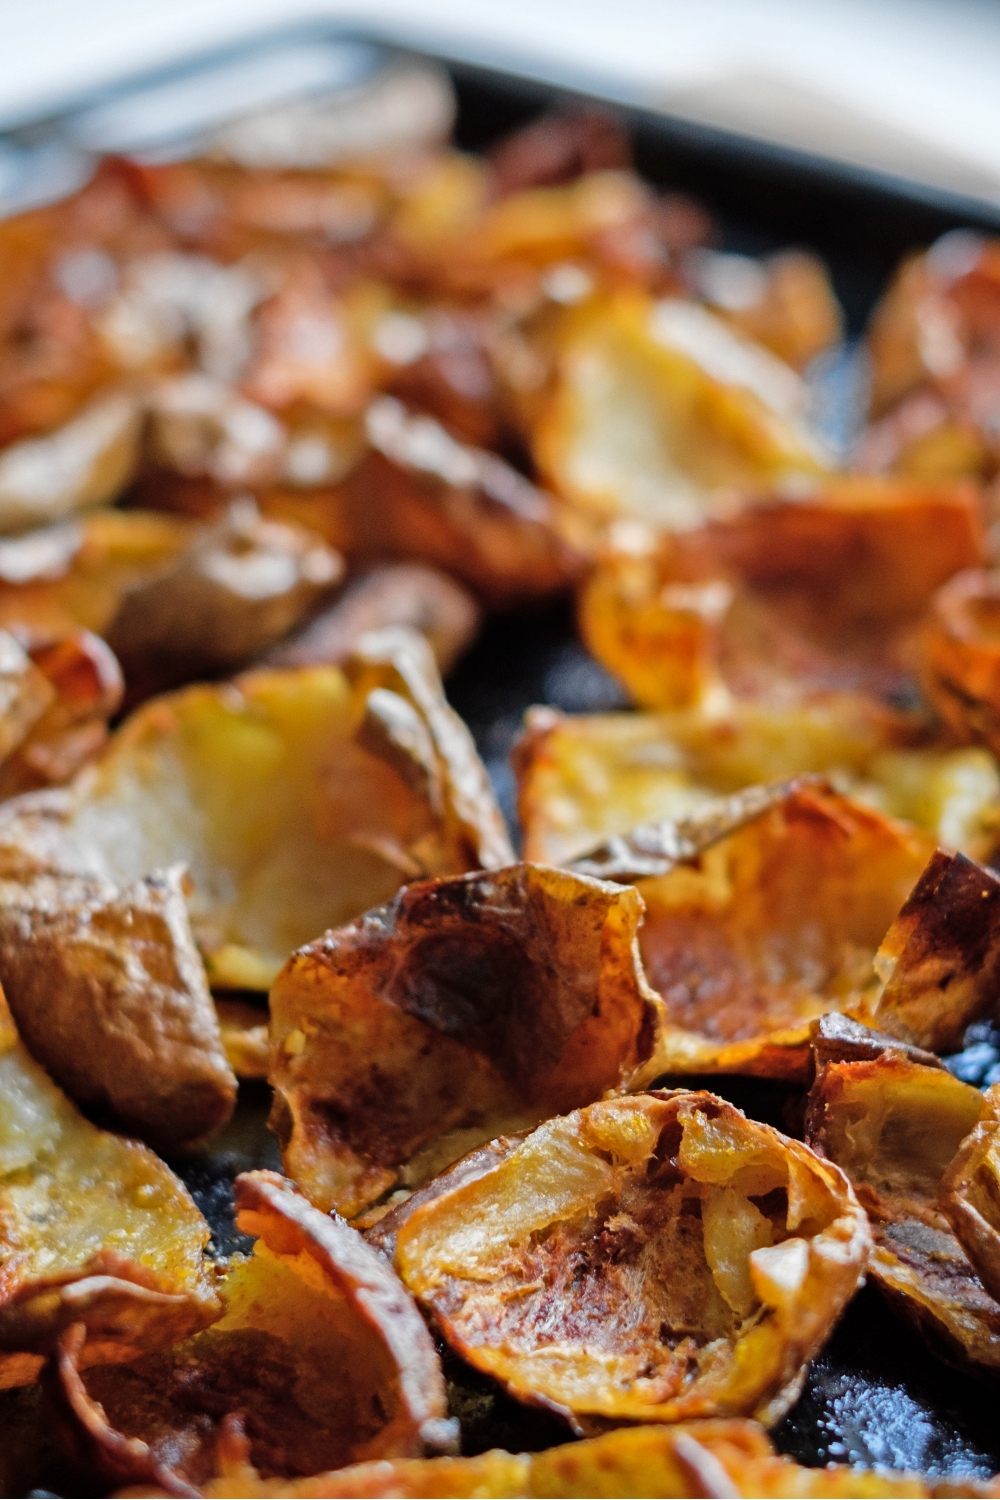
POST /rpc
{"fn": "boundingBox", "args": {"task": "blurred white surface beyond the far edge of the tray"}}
[0,0,1000,204]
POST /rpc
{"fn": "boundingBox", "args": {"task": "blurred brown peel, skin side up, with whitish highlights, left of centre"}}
[105,500,343,701]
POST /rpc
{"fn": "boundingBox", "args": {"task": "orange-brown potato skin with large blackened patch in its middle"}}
[271,866,660,1215]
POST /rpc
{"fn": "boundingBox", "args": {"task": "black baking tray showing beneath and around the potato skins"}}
[0,24,1000,1496]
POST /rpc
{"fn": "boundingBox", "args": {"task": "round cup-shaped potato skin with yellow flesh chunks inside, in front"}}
[380,1091,870,1434]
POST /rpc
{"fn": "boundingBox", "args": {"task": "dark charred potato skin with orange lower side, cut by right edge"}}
[859,849,1000,1052]
